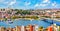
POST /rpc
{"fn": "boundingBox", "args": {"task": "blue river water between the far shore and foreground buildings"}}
[0,19,60,28]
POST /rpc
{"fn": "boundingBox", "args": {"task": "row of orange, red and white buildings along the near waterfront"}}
[0,24,60,31]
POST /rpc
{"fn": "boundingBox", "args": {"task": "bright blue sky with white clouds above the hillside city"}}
[0,0,60,9]
